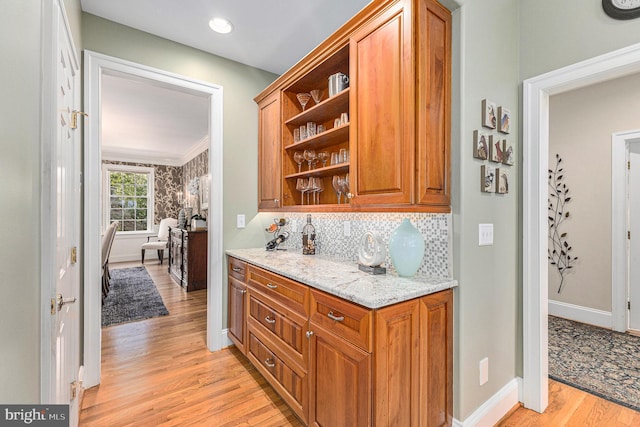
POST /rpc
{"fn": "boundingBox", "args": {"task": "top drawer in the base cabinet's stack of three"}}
[247,265,309,314]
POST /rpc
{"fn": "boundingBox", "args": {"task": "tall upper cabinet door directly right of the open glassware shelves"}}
[349,0,414,205]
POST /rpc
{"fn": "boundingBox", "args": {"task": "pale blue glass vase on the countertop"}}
[389,218,424,277]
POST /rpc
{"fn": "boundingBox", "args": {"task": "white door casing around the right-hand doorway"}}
[522,44,640,412]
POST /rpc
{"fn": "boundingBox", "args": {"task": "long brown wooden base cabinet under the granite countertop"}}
[229,258,453,427]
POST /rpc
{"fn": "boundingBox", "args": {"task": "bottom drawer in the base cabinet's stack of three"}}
[248,332,308,422]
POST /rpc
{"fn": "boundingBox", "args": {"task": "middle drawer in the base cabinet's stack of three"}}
[249,290,309,370]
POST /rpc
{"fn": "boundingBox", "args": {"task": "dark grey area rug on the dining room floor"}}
[102,267,169,327]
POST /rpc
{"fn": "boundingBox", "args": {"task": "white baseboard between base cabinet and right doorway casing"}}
[453,378,522,427]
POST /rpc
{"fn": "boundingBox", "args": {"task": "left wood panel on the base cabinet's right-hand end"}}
[373,300,426,426]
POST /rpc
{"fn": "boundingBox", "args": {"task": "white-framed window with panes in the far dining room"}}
[103,165,154,232]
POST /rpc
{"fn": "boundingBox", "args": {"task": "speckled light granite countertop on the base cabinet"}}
[226,248,458,308]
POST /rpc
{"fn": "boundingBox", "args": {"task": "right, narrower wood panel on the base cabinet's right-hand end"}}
[419,289,453,427]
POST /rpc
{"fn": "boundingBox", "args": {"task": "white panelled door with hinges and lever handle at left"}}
[43,0,81,426]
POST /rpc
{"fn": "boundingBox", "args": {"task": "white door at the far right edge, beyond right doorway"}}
[627,143,640,331]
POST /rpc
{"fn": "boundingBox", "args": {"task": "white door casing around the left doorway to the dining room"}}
[83,51,224,388]
